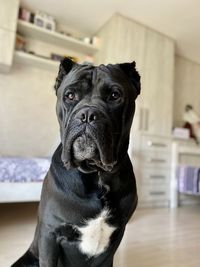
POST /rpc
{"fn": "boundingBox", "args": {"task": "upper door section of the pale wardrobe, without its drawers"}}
[96,15,174,135]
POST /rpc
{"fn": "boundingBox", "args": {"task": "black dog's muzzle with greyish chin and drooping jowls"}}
[62,107,115,174]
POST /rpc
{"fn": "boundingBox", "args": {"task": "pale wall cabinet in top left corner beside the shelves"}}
[0,0,19,72]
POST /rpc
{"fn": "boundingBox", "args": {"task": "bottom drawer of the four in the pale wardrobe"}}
[138,186,169,201]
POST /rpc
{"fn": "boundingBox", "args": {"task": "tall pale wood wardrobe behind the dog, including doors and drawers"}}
[96,14,174,207]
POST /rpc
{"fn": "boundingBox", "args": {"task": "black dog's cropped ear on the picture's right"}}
[119,61,141,95]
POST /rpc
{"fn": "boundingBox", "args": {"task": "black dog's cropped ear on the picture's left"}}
[54,57,76,94]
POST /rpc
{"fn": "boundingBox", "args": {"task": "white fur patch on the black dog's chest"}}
[78,209,116,257]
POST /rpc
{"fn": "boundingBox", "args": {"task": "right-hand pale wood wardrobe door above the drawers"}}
[140,29,174,135]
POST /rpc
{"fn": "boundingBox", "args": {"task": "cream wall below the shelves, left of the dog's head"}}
[0,64,59,156]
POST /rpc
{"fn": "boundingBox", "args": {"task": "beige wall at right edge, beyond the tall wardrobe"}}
[174,56,200,126]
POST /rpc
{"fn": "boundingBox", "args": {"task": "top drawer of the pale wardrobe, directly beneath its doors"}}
[141,135,171,152]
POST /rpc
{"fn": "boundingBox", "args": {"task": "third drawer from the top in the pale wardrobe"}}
[138,169,170,185]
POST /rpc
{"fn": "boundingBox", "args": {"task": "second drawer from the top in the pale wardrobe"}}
[141,151,171,169]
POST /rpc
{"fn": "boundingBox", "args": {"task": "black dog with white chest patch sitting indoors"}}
[12,59,140,267]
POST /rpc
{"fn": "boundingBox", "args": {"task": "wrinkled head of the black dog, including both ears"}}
[55,59,140,172]
